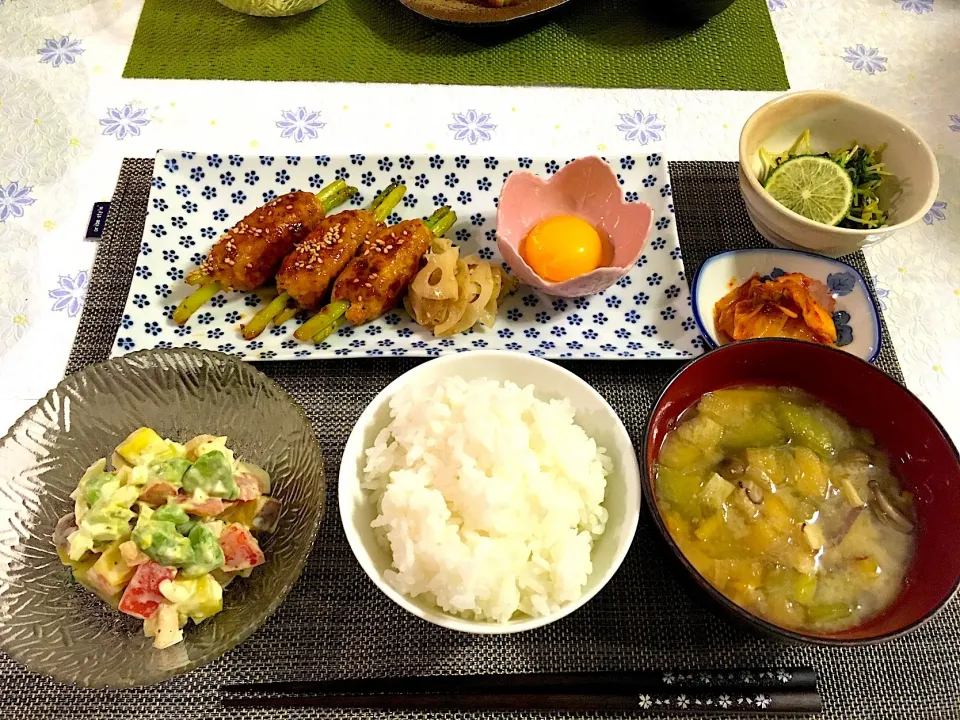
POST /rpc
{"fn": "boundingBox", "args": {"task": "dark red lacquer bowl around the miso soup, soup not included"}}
[643,339,960,645]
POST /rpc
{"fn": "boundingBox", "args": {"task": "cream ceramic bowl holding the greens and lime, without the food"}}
[740,90,940,257]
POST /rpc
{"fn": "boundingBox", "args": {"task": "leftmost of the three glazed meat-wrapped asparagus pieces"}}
[173,180,357,325]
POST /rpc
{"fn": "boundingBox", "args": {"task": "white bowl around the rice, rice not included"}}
[339,350,640,634]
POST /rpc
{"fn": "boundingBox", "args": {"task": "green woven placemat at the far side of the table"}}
[124,0,789,90]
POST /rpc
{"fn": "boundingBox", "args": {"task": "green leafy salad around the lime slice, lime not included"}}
[759,129,893,230]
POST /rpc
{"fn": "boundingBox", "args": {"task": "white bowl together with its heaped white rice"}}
[339,351,640,633]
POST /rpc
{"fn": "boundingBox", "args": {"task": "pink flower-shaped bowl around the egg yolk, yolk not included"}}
[497,157,653,297]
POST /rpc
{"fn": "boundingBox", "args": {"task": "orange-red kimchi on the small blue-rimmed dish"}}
[713,273,837,345]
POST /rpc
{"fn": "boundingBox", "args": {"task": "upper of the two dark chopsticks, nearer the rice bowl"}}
[220,667,817,695]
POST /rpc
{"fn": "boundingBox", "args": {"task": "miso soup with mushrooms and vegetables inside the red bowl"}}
[656,386,915,633]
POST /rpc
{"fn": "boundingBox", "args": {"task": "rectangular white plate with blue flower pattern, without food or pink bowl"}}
[113,151,702,361]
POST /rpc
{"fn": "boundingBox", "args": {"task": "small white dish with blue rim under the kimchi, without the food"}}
[692,249,880,362]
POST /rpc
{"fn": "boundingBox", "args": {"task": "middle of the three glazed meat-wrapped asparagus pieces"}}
[243,183,407,340]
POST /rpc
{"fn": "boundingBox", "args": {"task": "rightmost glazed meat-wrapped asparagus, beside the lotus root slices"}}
[294,207,457,343]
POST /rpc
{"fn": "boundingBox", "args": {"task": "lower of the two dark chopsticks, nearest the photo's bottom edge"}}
[222,688,823,715]
